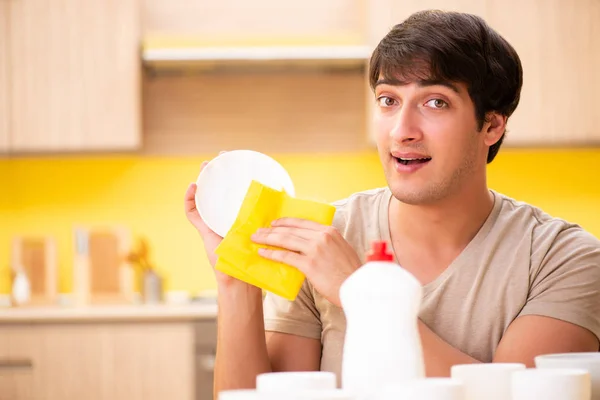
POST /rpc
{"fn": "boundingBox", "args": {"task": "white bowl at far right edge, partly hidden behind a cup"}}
[535,352,600,400]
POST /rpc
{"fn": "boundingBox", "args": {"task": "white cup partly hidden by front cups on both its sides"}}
[451,363,525,400]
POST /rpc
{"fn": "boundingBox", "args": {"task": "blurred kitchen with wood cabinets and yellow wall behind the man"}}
[0,0,600,400]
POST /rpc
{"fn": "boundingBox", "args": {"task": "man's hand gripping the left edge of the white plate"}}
[184,161,238,285]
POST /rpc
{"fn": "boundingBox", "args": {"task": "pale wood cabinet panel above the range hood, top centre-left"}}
[143,0,366,46]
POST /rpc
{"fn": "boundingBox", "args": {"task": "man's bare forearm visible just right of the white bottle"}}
[419,320,480,377]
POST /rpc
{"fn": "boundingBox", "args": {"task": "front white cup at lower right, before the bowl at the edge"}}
[512,368,592,400]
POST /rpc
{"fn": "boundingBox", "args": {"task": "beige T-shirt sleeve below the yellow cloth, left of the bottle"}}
[263,280,322,340]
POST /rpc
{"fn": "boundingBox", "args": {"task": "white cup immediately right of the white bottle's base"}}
[376,378,465,400]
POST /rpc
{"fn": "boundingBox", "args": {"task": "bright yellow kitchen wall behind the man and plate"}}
[0,149,600,294]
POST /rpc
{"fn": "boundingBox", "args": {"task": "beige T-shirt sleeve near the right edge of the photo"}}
[520,227,600,339]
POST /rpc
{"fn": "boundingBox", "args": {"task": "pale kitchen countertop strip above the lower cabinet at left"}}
[0,301,217,324]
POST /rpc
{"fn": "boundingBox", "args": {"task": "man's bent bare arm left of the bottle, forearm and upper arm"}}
[214,281,321,399]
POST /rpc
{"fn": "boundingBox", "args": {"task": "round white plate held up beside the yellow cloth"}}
[196,150,295,236]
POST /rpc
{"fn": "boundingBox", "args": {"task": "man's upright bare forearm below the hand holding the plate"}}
[214,281,271,398]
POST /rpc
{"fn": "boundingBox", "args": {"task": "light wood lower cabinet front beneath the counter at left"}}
[27,323,195,400]
